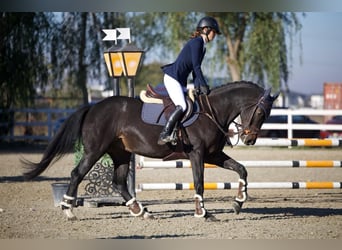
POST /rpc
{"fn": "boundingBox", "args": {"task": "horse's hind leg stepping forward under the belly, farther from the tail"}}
[109,150,152,218]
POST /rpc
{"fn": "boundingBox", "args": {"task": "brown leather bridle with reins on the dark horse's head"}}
[199,92,270,147]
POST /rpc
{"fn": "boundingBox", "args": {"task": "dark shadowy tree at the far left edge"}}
[0,13,51,109]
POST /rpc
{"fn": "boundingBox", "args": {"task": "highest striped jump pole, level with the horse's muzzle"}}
[238,138,342,147]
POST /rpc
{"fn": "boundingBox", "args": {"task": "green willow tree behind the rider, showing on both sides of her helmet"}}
[135,12,301,89]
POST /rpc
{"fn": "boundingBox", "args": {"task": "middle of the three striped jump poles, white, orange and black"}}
[139,160,342,168]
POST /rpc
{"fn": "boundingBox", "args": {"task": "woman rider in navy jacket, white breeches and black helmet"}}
[158,16,221,145]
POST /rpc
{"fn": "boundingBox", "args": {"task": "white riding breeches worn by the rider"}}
[164,74,186,112]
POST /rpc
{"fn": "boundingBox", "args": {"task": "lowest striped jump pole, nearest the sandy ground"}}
[137,182,342,191]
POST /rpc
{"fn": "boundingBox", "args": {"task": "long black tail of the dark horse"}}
[21,106,90,180]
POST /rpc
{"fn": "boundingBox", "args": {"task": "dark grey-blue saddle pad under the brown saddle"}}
[141,102,199,127]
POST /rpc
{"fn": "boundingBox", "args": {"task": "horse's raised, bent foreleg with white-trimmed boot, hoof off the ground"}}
[224,159,247,214]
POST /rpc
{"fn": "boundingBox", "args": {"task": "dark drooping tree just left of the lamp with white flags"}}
[51,12,125,104]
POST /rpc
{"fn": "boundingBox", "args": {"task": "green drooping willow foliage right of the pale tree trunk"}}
[245,13,298,89]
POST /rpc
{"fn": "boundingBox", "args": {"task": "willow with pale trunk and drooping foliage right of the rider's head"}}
[214,12,301,89]
